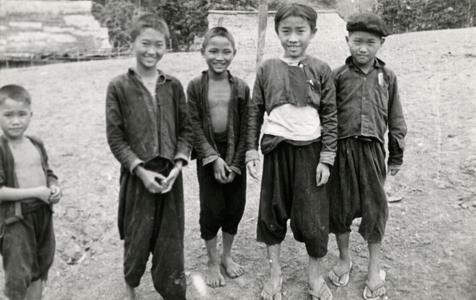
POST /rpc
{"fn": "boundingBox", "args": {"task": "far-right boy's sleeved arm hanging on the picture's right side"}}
[388,75,407,174]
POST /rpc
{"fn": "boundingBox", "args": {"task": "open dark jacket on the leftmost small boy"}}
[0,135,58,229]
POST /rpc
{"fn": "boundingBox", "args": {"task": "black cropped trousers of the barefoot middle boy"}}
[197,137,246,241]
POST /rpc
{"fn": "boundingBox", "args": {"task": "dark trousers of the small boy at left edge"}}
[0,205,55,299]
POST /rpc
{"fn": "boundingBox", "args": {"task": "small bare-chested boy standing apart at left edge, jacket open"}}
[0,85,61,300]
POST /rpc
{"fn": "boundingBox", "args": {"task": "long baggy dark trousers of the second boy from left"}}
[119,158,186,300]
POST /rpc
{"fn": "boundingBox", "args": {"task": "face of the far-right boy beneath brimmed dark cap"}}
[346,31,384,67]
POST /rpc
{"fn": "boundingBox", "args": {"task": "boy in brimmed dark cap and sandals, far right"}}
[329,13,407,299]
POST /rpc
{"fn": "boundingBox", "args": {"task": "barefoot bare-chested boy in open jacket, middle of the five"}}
[187,27,250,287]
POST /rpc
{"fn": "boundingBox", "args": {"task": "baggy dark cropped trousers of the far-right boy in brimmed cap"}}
[328,137,388,243]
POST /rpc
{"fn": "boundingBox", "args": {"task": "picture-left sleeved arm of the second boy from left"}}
[106,83,143,173]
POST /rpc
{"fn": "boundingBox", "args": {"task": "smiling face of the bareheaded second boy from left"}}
[133,28,167,70]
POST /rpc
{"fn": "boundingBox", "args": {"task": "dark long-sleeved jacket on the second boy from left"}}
[106,69,191,171]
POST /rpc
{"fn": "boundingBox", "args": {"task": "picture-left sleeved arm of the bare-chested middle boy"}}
[187,82,219,165]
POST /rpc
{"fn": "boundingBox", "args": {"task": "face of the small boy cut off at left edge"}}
[0,98,32,140]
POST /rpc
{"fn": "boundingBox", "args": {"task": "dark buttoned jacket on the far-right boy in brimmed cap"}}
[333,57,407,165]
